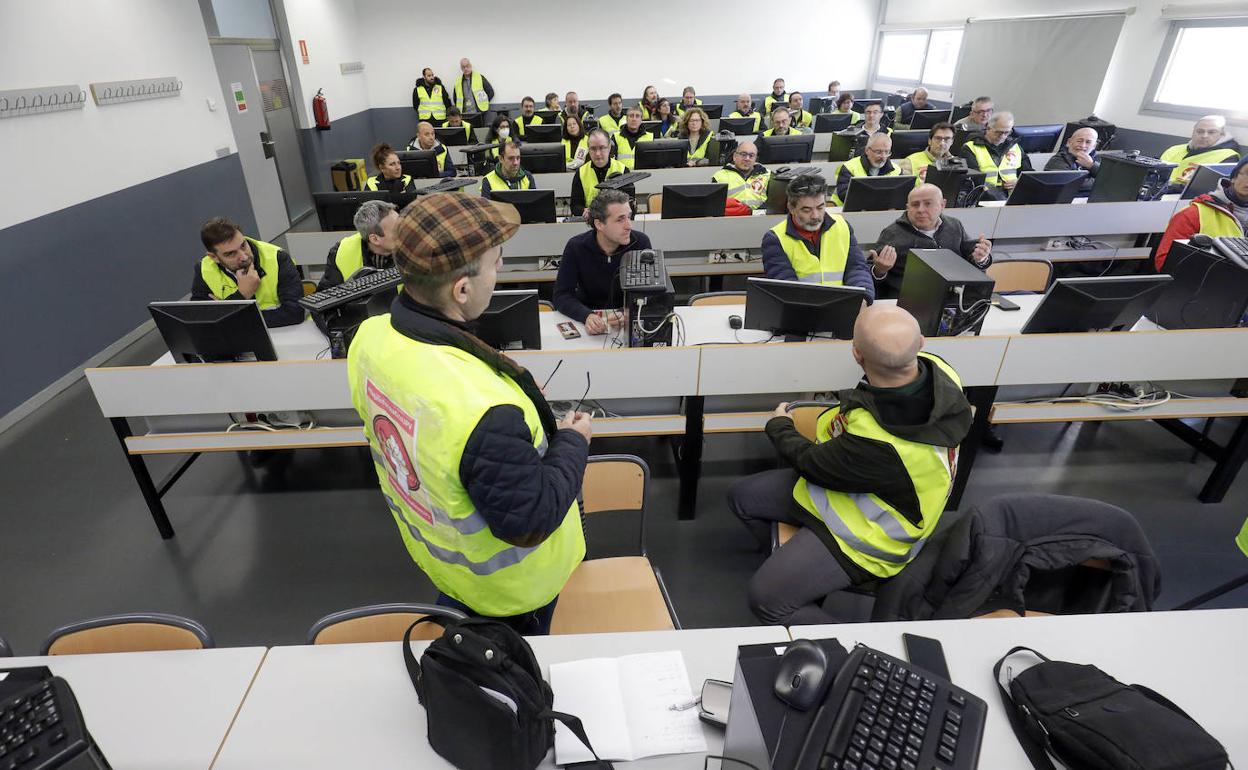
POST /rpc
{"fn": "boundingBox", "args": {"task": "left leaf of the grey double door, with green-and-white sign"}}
[212,45,288,241]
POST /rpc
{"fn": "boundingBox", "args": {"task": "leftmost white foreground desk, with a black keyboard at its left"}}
[0,646,265,770]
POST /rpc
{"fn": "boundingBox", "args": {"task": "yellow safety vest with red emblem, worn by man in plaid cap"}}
[347,316,585,616]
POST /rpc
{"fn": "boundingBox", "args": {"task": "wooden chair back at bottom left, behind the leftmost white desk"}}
[39,613,215,655]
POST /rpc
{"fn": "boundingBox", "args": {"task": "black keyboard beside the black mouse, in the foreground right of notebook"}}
[796,645,988,770]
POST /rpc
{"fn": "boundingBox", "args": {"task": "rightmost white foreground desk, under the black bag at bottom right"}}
[790,609,1248,770]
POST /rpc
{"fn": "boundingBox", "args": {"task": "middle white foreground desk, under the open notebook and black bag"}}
[213,626,789,770]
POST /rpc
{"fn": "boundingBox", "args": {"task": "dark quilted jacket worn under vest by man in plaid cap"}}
[391,293,589,547]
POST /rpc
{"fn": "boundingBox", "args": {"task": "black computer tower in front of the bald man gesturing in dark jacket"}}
[897,248,995,337]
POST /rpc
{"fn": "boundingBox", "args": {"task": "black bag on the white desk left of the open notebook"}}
[403,616,612,770]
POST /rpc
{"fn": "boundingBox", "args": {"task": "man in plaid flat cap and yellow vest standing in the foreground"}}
[347,195,592,634]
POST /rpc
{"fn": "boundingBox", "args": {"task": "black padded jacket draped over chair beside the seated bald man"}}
[871,494,1161,620]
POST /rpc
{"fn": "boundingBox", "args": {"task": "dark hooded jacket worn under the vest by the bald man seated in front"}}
[766,358,971,582]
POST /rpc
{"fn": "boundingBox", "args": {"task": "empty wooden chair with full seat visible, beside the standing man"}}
[550,454,680,634]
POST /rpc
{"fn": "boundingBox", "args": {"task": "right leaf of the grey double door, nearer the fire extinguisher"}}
[251,49,312,222]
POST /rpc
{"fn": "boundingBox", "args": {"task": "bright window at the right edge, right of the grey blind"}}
[1143,20,1248,120]
